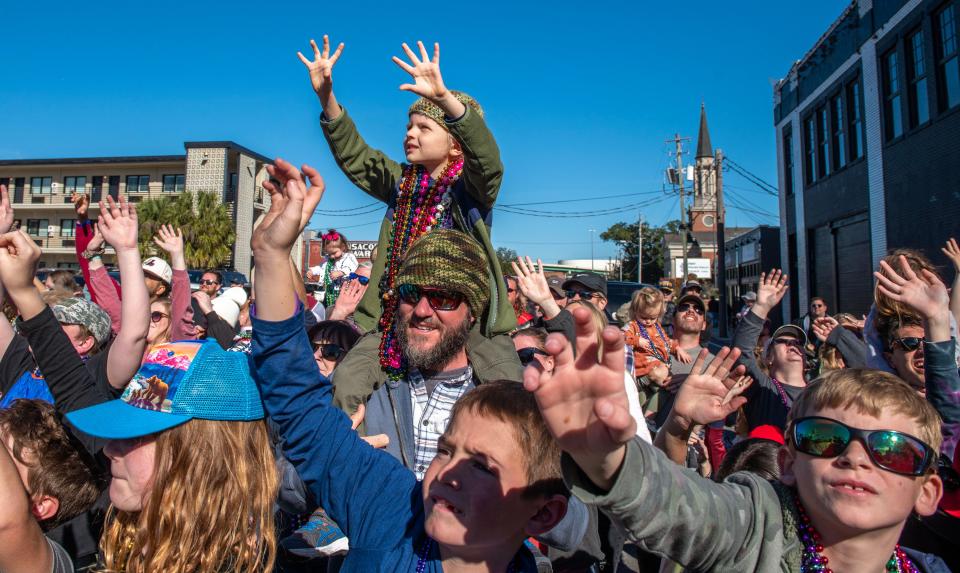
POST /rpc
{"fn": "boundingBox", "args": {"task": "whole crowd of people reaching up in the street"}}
[0,36,960,573]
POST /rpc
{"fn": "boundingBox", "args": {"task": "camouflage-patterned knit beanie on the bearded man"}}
[396,229,490,318]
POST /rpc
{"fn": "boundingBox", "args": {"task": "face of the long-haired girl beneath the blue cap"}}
[103,435,156,511]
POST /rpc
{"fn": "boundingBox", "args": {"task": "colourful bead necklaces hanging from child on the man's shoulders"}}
[378,157,463,380]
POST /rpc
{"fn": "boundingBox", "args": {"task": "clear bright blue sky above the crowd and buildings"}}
[0,0,847,261]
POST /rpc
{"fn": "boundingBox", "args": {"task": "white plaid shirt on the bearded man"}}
[407,365,474,480]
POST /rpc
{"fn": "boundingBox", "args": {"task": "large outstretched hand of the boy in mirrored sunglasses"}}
[524,308,637,489]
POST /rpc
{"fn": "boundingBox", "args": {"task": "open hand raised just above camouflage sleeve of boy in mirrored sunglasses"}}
[670,347,750,428]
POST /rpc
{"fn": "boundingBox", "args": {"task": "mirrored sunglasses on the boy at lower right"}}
[790,416,937,476]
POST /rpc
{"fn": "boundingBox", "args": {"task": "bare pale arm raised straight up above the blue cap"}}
[99,196,150,390]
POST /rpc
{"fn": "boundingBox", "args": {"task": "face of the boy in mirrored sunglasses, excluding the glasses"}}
[780,408,943,540]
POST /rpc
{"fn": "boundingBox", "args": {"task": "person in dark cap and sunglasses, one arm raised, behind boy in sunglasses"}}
[733,269,807,431]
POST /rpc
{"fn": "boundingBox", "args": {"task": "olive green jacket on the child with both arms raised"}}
[320,106,517,337]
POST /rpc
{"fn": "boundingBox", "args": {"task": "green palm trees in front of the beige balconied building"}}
[137,191,236,269]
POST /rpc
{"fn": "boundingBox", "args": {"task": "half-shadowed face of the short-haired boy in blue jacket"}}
[423,410,566,557]
